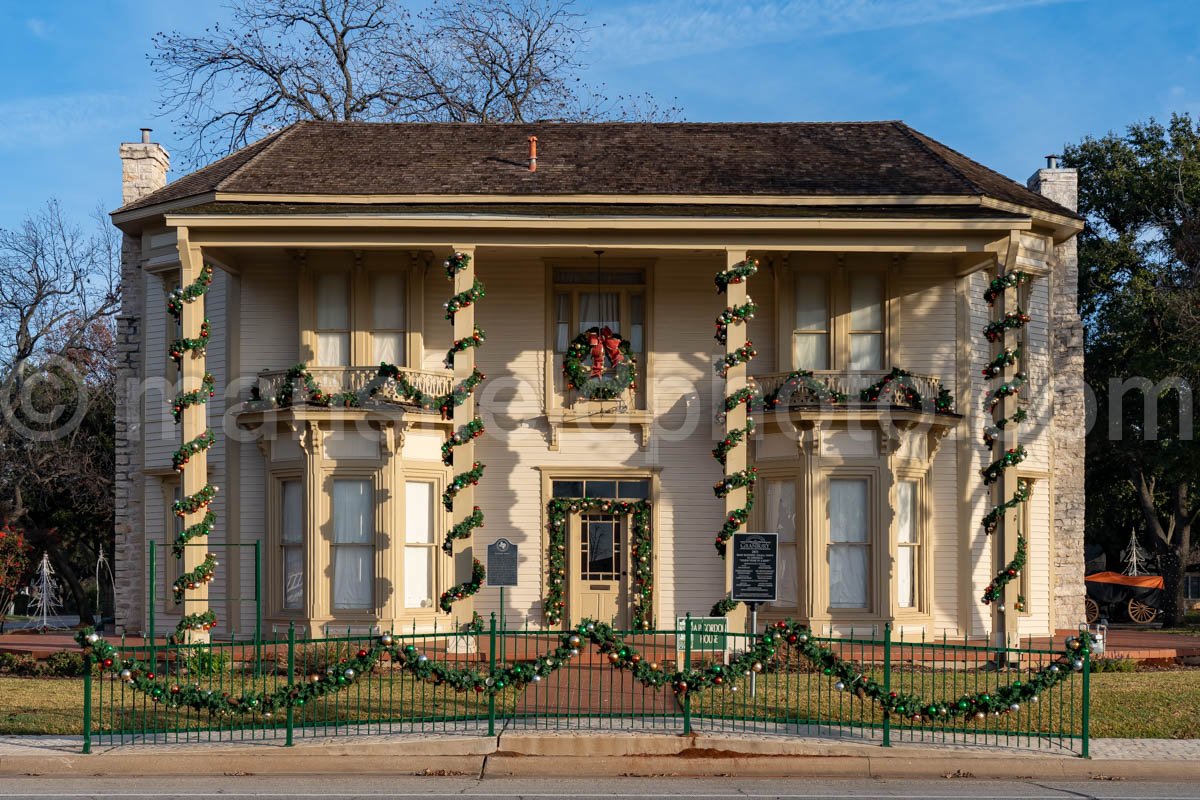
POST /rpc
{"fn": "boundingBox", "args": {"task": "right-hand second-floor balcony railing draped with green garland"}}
[750,369,955,414]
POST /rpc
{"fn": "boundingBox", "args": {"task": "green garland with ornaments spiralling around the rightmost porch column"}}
[979,270,1033,612]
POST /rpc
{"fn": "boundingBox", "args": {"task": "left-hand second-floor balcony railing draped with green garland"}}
[254,367,454,407]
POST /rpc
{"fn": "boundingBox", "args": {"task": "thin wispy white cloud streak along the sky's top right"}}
[592,0,1070,66]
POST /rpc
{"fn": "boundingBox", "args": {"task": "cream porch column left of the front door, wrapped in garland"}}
[450,245,475,620]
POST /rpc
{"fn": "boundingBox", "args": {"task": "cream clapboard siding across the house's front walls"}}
[136,244,1050,633]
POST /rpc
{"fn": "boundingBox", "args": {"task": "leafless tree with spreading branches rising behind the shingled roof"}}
[150,0,679,163]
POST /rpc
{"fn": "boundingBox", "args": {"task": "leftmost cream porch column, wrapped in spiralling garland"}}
[176,228,209,644]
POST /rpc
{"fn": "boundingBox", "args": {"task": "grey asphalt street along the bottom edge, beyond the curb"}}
[0,765,1200,800]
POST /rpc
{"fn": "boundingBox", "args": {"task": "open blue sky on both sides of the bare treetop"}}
[0,0,1200,227]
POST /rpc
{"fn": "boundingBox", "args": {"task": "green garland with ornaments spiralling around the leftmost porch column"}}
[167,264,217,639]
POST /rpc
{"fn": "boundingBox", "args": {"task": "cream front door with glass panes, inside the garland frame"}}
[568,512,629,630]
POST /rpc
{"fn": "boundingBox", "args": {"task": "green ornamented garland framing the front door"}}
[542,498,654,631]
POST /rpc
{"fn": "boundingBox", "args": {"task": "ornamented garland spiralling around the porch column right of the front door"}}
[712,258,762,616]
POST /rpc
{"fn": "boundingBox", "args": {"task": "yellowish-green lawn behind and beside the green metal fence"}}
[0,669,1200,739]
